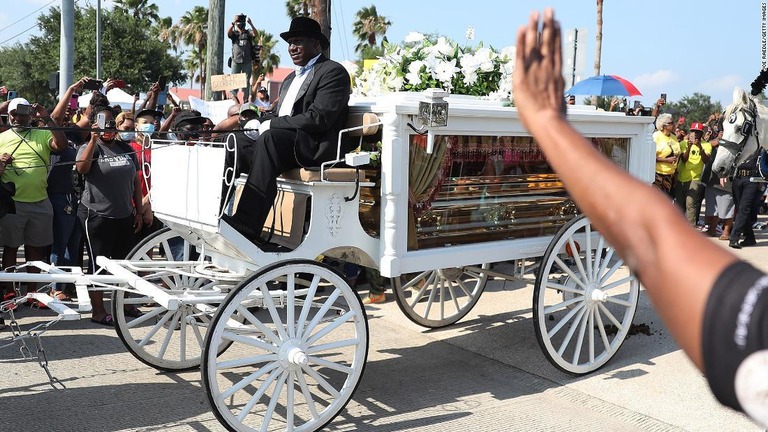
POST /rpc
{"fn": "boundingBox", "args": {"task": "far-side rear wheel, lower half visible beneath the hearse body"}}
[393,263,490,328]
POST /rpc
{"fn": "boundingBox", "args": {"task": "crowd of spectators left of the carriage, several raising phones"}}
[0,77,231,325]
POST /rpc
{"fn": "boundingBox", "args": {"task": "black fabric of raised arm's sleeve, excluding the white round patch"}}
[702,261,768,411]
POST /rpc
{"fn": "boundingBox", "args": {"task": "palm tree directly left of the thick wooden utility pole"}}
[160,6,208,93]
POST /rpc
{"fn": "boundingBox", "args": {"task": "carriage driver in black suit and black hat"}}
[222,17,350,243]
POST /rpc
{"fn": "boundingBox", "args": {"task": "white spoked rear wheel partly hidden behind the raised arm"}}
[533,216,640,374]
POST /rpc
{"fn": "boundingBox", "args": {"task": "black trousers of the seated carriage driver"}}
[234,129,303,232]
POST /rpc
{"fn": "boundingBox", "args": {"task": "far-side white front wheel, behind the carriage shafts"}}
[112,228,231,371]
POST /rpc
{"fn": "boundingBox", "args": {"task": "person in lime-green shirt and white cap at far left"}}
[0,98,68,300]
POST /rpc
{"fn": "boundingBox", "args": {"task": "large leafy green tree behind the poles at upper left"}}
[0,5,187,106]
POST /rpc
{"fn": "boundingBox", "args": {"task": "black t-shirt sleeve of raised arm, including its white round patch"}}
[702,261,768,426]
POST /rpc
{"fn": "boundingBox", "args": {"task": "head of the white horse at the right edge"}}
[712,87,768,178]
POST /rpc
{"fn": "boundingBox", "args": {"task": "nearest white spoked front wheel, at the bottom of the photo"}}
[202,260,368,431]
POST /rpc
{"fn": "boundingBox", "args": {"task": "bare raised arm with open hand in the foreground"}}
[513,9,736,370]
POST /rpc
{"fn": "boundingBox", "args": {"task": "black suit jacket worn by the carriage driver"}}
[269,55,351,166]
